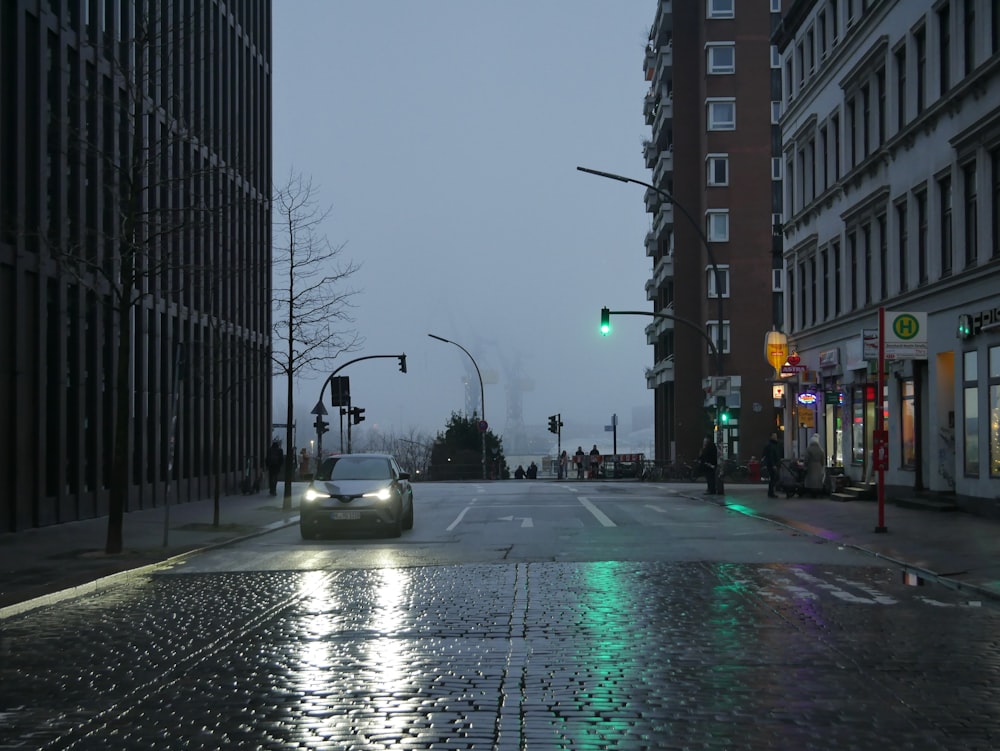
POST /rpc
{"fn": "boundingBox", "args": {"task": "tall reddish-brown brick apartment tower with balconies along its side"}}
[643,0,782,468]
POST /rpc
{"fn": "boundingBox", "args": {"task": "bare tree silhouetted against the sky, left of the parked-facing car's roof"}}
[271,170,363,509]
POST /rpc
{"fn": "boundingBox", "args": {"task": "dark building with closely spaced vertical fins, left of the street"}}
[0,0,271,532]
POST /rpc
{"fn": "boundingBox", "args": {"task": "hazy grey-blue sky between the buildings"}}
[272,0,656,454]
